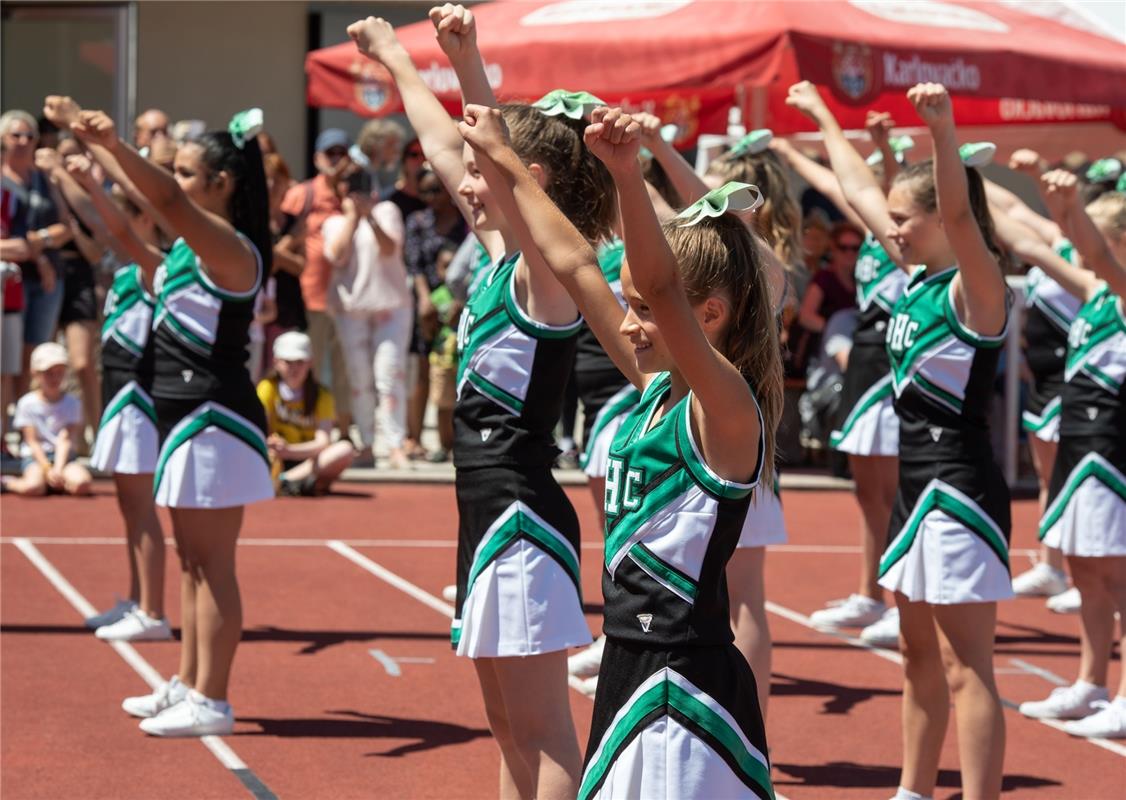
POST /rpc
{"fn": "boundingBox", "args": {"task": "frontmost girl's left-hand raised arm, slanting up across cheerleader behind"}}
[459,106,645,388]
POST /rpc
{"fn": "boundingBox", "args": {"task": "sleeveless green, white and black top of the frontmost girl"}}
[602,373,765,648]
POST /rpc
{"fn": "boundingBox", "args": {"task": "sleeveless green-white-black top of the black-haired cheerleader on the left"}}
[152,234,262,401]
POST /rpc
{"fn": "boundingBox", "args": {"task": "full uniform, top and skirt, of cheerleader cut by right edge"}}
[1040,285,1126,558]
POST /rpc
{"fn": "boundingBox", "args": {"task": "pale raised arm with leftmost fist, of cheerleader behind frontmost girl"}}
[348,17,504,259]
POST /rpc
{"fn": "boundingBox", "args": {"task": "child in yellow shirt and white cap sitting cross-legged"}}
[258,331,355,497]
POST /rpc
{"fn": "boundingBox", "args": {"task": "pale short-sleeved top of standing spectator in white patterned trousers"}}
[321,201,411,313]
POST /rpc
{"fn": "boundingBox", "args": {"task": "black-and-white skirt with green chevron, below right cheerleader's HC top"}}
[879,462,1012,605]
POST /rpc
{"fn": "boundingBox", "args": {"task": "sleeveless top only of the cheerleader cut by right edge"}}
[1060,284,1126,438]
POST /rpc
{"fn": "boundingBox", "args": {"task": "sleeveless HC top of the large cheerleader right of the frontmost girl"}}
[887,267,1008,462]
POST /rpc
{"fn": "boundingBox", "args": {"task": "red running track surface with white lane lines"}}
[0,483,1126,800]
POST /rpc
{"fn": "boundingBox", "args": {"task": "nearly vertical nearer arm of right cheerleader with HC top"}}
[908,83,1007,336]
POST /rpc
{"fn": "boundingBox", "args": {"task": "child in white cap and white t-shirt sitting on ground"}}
[2,341,91,497]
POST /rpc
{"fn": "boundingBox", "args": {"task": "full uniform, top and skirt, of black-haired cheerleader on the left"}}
[152,237,274,508]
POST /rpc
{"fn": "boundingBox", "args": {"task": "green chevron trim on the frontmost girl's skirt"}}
[578,678,775,800]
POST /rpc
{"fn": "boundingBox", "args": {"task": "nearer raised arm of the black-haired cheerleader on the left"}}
[68,112,258,292]
